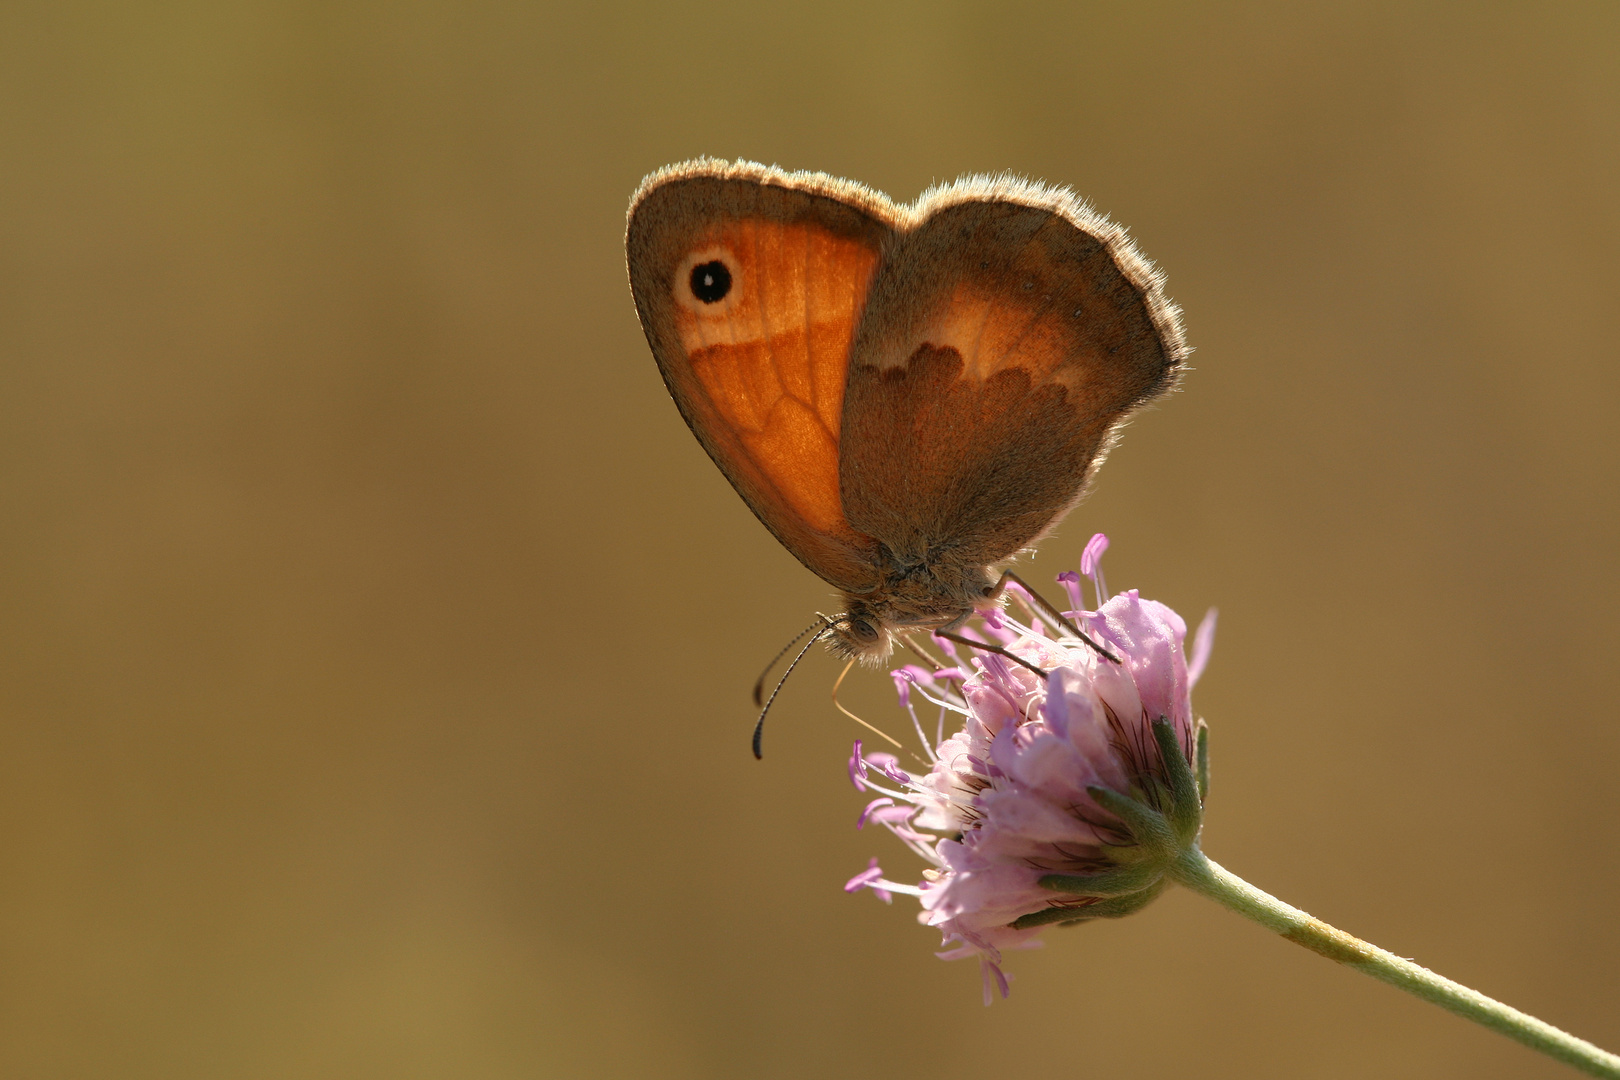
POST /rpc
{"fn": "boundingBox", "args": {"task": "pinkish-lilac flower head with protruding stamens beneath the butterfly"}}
[846,534,1213,1004]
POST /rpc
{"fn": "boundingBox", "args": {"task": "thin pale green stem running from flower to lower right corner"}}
[1170,845,1620,1078]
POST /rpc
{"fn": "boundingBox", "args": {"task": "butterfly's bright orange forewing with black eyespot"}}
[625,160,894,593]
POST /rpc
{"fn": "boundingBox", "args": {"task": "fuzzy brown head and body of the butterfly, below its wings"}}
[831,559,993,664]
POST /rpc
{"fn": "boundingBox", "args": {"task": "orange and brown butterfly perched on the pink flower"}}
[625,159,1187,659]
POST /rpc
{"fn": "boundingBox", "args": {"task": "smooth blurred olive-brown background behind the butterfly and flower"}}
[0,0,1620,1080]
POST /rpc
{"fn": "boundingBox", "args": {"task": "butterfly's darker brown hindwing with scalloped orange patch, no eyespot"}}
[841,180,1186,565]
